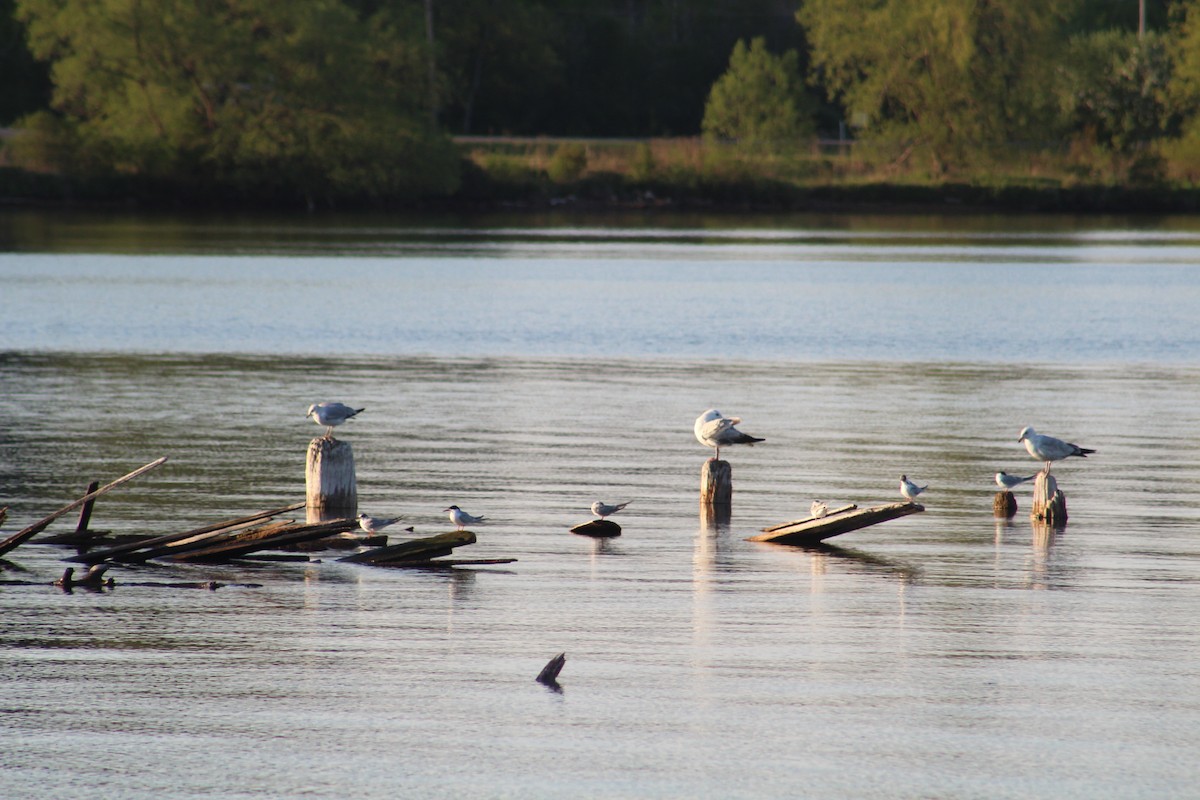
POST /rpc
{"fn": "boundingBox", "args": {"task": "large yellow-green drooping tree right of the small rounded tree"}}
[797,0,1070,170]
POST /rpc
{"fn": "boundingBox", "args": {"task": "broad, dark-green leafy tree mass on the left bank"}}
[18,0,457,203]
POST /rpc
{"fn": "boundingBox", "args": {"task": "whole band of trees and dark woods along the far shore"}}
[0,0,1200,206]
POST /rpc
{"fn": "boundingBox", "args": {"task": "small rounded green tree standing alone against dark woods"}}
[701,37,816,146]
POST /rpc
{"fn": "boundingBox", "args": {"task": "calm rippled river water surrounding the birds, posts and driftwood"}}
[0,211,1200,800]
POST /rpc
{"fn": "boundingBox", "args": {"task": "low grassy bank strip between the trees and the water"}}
[0,137,1200,213]
